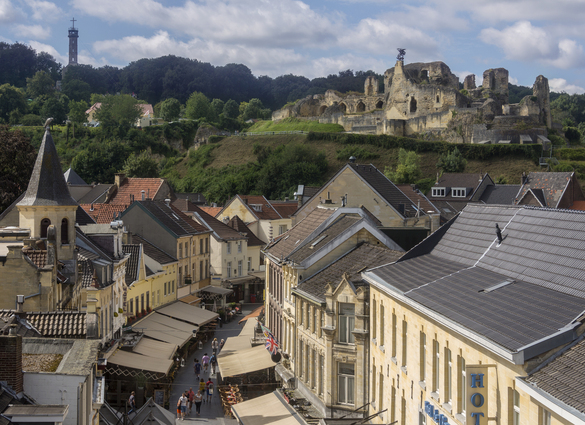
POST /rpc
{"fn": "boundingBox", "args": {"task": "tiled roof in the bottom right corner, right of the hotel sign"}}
[525,339,585,413]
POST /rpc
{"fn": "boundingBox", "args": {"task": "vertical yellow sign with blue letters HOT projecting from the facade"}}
[465,365,488,425]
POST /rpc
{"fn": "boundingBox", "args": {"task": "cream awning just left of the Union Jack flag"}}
[217,338,275,378]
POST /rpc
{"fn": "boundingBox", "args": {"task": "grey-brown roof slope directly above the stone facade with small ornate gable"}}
[294,243,404,302]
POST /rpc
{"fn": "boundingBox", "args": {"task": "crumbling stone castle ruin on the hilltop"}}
[272,60,551,143]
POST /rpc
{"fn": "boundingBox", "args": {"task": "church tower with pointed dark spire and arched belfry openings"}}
[16,128,78,261]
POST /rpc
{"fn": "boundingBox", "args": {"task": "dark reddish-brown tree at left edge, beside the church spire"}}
[0,126,36,212]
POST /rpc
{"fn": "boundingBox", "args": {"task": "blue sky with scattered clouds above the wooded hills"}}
[0,0,585,94]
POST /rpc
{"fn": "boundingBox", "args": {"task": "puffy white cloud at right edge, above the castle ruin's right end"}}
[479,21,585,68]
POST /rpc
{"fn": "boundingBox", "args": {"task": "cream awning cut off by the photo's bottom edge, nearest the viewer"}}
[232,391,305,425]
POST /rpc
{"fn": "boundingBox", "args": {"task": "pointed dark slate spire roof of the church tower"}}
[18,130,77,206]
